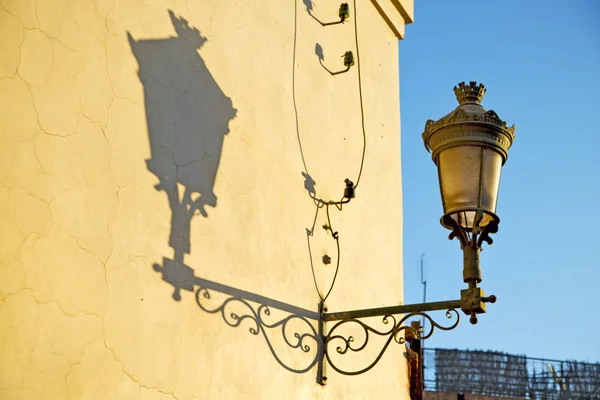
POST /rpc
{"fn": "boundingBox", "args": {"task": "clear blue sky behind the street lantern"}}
[399,0,600,362]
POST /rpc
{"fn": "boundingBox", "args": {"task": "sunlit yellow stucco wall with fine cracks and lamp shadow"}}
[0,0,412,400]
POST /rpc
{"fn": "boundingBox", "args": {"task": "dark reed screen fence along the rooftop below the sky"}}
[424,349,600,400]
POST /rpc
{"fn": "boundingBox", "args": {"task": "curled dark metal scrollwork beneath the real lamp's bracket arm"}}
[324,308,460,375]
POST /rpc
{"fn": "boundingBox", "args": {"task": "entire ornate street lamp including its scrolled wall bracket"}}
[317,82,515,384]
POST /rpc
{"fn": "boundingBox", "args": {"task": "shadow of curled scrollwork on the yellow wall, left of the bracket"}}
[196,287,321,374]
